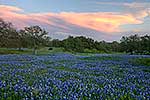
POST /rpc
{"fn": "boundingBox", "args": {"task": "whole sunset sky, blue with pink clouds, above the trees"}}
[0,0,150,41]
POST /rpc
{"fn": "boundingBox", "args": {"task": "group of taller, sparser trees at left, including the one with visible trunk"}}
[0,19,50,54]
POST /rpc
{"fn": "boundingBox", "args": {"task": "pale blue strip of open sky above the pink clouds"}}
[0,0,150,12]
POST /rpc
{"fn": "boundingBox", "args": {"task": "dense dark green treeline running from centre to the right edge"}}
[49,35,150,54]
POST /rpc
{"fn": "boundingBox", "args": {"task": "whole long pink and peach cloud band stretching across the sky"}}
[0,5,148,34]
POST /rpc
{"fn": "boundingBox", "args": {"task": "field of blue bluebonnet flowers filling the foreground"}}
[0,53,150,100]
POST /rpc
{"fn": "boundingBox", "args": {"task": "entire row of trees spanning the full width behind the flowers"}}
[0,19,150,54]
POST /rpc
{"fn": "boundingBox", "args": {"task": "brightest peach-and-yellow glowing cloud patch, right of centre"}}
[58,12,142,33]
